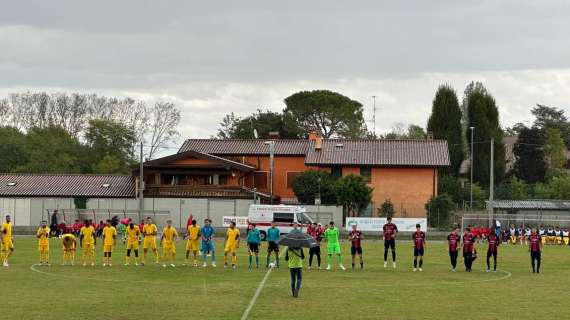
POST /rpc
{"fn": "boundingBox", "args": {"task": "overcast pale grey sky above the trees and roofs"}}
[0,0,570,146]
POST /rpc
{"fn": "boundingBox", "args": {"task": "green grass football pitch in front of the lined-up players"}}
[0,237,570,320]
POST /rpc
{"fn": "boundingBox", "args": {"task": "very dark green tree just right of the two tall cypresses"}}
[513,127,546,183]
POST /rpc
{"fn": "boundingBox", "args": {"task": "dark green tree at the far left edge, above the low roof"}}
[0,127,28,172]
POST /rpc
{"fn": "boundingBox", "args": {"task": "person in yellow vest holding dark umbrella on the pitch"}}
[278,232,318,298]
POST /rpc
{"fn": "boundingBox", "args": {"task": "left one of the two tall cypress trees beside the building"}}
[427,85,464,176]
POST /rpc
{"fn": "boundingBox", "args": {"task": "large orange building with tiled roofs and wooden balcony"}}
[140,134,449,217]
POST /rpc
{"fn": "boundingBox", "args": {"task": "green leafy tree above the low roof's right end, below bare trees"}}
[85,120,136,173]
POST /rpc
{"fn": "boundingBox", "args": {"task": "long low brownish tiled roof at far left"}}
[0,173,136,198]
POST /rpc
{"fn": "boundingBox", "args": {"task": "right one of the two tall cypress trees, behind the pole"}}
[466,89,505,187]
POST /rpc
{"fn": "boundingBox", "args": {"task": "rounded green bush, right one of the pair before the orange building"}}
[335,174,373,216]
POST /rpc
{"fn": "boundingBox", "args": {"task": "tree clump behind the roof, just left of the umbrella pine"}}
[217,110,305,139]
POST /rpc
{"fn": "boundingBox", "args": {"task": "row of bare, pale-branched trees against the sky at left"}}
[0,92,180,159]
